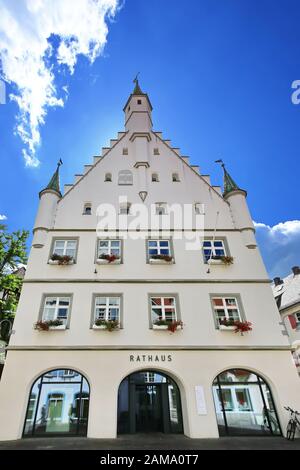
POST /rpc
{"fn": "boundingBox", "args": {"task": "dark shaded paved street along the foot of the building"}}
[0,434,300,451]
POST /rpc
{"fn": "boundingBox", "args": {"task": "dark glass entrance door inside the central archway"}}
[135,384,163,432]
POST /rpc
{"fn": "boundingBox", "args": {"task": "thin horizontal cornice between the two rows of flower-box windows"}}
[23,278,272,284]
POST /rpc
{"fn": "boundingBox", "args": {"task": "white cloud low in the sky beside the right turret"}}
[254,220,300,277]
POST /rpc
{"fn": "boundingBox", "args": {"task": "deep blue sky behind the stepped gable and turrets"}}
[0,0,300,277]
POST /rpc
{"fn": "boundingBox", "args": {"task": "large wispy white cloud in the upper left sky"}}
[0,0,119,167]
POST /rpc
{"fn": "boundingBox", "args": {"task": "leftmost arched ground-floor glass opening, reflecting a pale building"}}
[23,369,90,437]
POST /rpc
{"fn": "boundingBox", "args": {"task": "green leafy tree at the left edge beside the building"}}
[0,225,29,339]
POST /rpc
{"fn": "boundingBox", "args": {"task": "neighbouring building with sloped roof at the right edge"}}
[272,266,300,375]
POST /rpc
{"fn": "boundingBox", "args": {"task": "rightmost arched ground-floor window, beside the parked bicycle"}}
[213,369,282,436]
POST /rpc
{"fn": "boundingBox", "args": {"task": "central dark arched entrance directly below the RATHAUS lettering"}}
[118,370,183,434]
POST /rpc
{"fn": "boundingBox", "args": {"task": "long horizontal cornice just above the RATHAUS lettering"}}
[6,344,291,352]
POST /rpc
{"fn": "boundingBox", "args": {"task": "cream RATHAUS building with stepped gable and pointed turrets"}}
[0,82,300,440]
